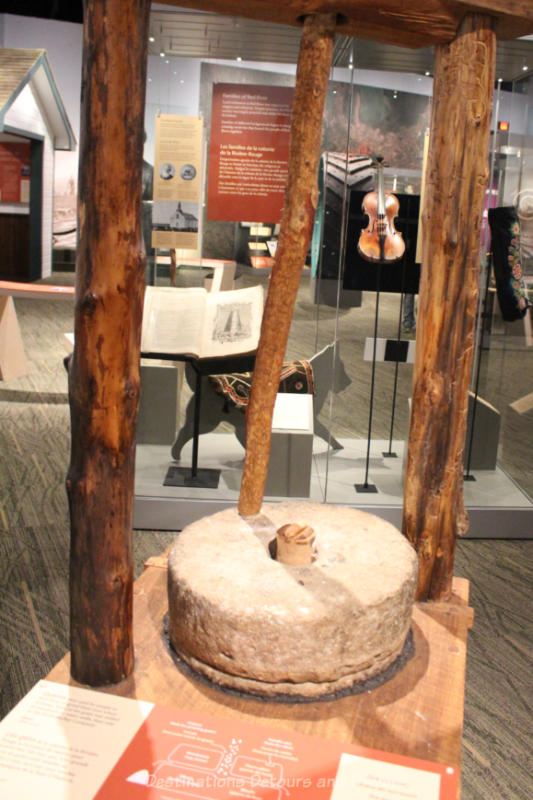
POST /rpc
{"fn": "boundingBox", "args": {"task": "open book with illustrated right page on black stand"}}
[141,286,263,358]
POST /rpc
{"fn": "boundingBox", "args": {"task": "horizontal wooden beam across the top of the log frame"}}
[159,0,533,48]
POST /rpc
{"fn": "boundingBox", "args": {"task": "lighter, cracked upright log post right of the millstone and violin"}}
[403,14,496,600]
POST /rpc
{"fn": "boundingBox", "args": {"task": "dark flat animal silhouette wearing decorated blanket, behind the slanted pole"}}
[171,343,350,461]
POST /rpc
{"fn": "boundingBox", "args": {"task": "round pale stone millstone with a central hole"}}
[168,502,417,697]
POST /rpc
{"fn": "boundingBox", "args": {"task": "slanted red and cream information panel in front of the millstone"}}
[0,681,458,800]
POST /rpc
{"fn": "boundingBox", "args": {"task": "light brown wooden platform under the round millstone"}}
[47,556,473,792]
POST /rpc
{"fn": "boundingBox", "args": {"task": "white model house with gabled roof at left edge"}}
[0,48,76,281]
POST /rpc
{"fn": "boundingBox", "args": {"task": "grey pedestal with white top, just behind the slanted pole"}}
[265,394,313,497]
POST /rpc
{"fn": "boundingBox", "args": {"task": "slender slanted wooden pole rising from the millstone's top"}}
[238,14,336,516]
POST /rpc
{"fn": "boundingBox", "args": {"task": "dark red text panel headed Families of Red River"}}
[207,83,294,222]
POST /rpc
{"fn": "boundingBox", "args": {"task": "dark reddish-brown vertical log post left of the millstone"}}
[67,0,149,686]
